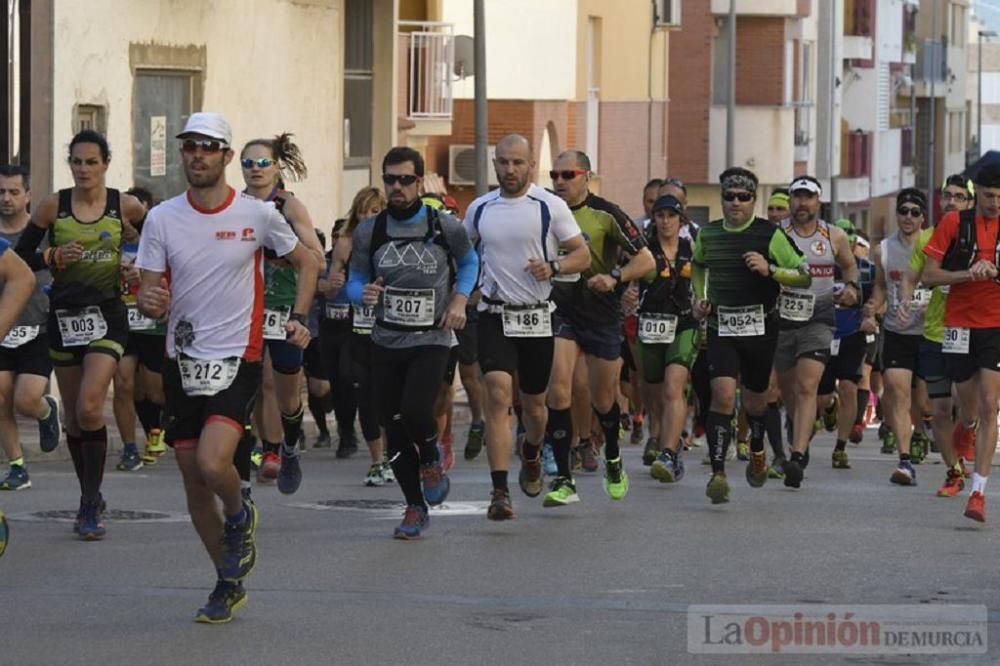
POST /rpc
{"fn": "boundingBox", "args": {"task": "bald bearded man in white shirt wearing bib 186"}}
[465,134,590,520]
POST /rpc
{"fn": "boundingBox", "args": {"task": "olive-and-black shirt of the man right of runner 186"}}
[552,192,646,325]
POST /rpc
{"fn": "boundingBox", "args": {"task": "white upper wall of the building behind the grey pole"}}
[441,0,576,99]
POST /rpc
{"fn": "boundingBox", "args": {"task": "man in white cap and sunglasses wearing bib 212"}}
[136,113,319,624]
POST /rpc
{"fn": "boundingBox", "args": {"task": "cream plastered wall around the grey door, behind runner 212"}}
[53,0,343,230]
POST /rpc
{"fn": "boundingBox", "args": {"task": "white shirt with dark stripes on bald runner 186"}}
[464,185,580,309]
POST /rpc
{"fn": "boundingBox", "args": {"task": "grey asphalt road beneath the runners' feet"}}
[0,420,1000,666]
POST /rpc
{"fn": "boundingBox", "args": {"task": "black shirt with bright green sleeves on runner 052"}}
[694,217,810,328]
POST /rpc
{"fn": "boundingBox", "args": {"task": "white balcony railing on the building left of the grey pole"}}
[399,21,455,120]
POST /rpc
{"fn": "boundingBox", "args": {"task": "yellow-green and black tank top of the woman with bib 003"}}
[49,187,122,307]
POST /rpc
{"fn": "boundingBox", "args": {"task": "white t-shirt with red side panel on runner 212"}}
[136,188,298,361]
